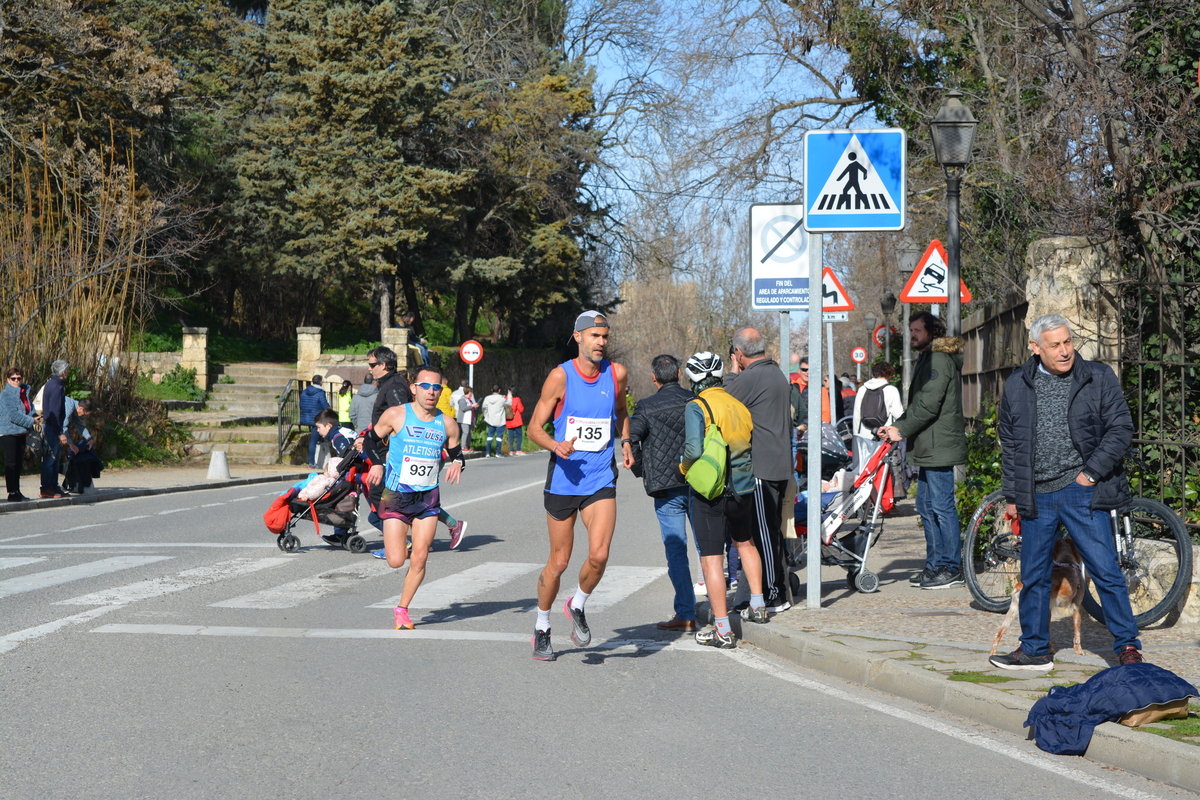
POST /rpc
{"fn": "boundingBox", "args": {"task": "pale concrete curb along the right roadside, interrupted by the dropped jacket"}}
[730,616,1200,792]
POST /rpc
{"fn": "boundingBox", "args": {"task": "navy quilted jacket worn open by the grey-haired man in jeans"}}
[1000,354,1133,519]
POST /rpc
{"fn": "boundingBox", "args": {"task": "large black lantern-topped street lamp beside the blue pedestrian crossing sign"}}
[929,90,979,336]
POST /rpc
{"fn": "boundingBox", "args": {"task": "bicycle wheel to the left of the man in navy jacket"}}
[962,492,1021,614]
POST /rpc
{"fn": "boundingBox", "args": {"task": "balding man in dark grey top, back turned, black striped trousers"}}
[725,327,796,613]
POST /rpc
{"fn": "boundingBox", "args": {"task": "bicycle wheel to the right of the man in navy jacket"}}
[1084,498,1192,627]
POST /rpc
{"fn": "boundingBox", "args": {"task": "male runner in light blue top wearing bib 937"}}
[362,367,466,631]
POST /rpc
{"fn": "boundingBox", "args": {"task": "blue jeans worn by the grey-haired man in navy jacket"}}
[1020,483,1141,656]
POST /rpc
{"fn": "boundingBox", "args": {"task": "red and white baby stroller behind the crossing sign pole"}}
[790,426,899,595]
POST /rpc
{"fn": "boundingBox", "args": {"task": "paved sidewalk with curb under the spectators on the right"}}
[720,503,1200,792]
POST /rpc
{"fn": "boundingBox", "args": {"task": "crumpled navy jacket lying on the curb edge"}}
[1025,663,1196,756]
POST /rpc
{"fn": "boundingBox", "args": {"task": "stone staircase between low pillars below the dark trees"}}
[170,363,296,464]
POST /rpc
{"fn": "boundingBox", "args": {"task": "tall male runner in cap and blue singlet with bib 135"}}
[529,311,632,661]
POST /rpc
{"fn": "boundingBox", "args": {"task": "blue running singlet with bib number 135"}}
[546,359,617,497]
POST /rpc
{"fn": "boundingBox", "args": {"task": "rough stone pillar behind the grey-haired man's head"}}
[1025,236,1121,371]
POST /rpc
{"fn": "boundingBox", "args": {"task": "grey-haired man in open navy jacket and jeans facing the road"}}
[990,314,1142,670]
